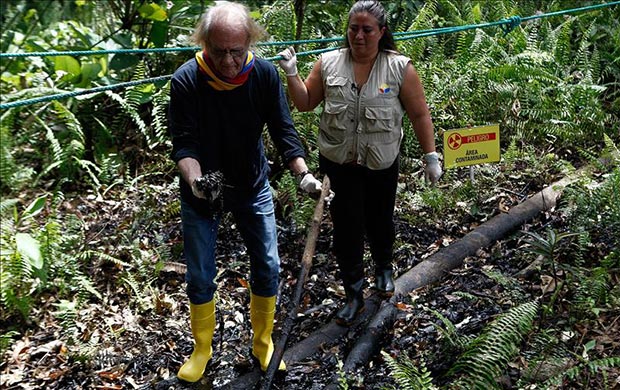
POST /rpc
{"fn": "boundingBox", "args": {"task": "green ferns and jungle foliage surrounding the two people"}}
[0,0,620,388]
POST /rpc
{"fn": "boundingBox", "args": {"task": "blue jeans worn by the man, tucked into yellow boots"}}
[181,181,280,305]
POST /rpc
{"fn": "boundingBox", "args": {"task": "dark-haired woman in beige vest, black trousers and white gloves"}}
[280,0,442,326]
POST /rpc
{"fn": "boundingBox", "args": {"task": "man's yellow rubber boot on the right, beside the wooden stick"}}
[250,294,286,371]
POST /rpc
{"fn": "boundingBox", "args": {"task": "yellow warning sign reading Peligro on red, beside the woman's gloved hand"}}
[443,124,499,169]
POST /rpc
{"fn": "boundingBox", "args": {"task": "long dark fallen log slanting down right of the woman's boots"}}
[332,174,580,387]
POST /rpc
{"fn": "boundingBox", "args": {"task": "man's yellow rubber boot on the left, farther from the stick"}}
[177,299,215,382]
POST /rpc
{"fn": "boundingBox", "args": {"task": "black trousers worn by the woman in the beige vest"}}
[319,156,399,286]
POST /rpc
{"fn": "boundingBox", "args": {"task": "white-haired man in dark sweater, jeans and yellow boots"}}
[169,2,321,382]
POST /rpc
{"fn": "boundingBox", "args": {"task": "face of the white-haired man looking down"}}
[207,25,249,78]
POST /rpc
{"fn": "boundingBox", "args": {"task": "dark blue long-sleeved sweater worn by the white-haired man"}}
[169,58,305,210]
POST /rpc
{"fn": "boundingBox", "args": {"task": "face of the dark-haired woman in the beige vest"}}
[347,12,385,55]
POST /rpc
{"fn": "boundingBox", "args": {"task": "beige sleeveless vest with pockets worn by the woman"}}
[318,49,410,170]
